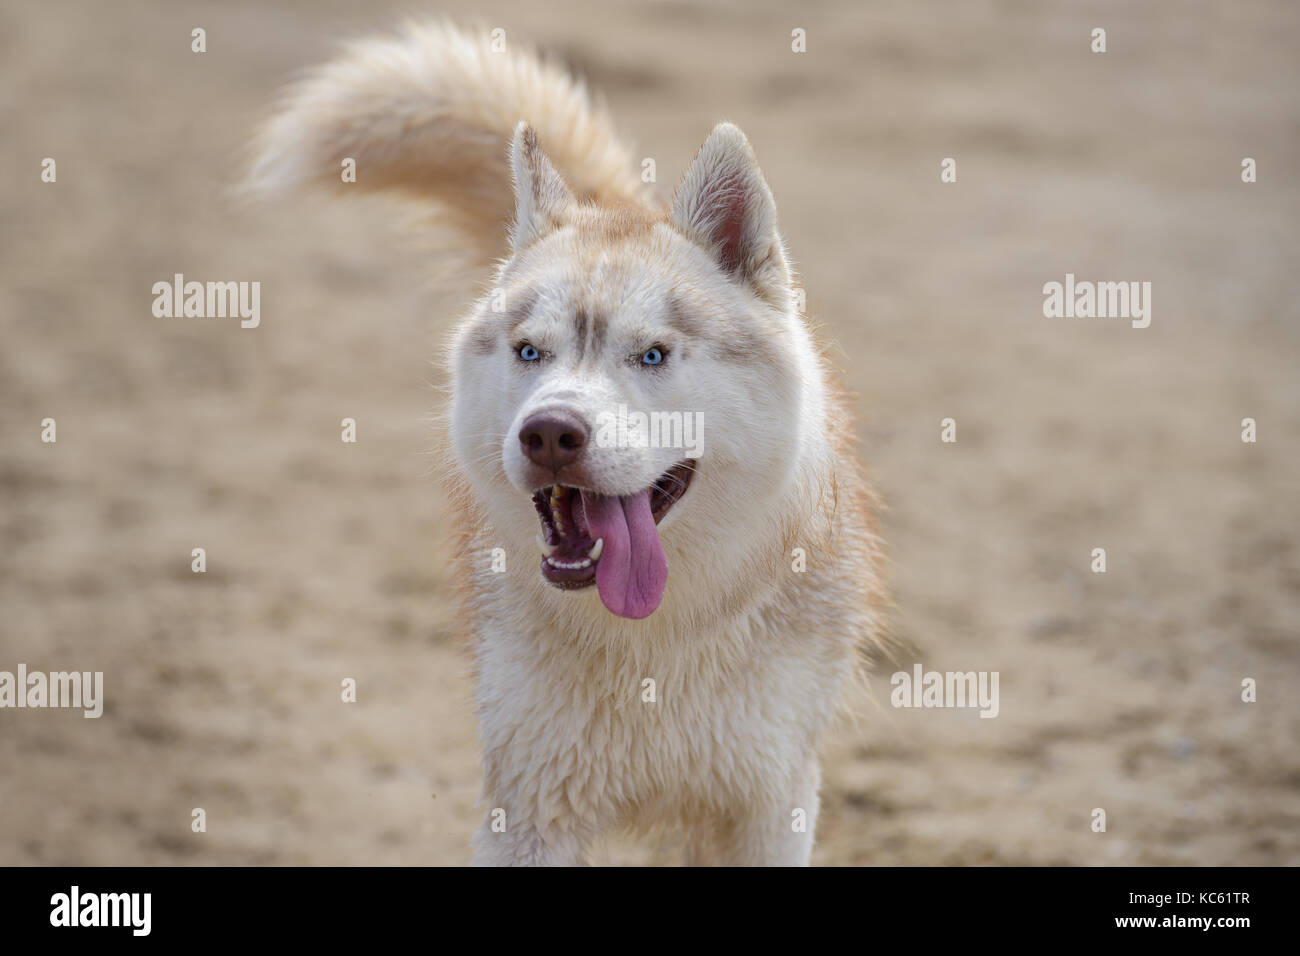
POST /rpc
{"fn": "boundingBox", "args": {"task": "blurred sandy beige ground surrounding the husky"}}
[0,0,1300,865]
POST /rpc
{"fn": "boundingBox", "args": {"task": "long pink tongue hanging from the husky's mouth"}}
[582,489,668,618]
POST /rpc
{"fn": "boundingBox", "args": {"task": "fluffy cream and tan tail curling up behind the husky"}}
[247,22,651,261]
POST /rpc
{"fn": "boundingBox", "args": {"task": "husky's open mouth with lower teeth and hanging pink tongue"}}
[533,460,696,618]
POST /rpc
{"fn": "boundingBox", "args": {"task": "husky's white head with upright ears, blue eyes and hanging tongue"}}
[451,124,816,618]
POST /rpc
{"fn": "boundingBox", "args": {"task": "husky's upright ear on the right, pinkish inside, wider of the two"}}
[672,122,790,303]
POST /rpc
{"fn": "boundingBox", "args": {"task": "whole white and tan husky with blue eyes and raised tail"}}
[252,23,884,865]
